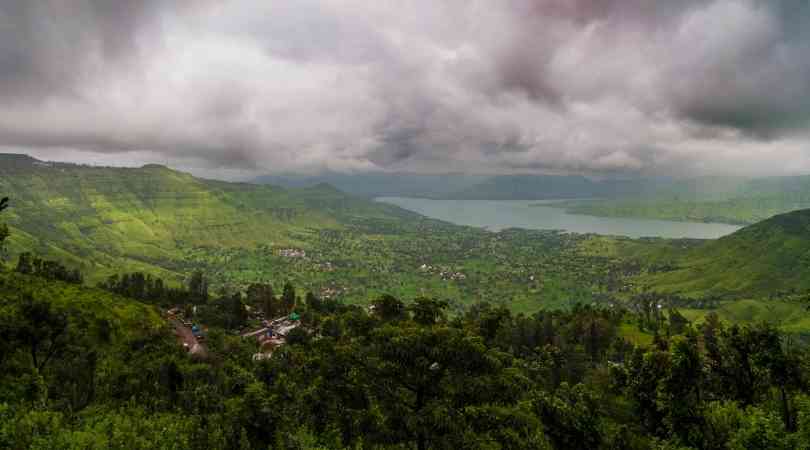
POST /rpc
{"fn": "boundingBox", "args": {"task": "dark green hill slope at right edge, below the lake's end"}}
[644,209,810,298]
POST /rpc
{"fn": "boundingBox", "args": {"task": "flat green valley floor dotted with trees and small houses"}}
[188,219,619,312]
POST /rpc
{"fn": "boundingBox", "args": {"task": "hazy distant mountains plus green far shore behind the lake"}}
[254,172,810,225]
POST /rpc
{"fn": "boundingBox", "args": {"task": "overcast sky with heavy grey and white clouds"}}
[0,0,810,178]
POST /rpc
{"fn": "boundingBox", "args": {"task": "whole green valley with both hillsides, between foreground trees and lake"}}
[0,155,810,331]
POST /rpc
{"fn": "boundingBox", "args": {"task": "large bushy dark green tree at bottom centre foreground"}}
[364,323,538,450]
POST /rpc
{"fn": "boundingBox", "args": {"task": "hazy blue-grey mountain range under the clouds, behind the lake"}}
[252,172,810,201]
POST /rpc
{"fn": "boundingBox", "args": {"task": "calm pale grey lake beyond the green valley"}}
[377,197,740,239]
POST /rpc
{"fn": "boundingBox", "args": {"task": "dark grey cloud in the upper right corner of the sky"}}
[668,1,810,138]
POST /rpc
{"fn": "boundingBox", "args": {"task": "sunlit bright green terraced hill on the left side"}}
[0,154,416,279]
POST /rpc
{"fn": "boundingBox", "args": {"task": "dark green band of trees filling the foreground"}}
[0,278,810,449]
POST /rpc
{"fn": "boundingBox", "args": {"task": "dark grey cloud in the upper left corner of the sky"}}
[0,0,166,101]
